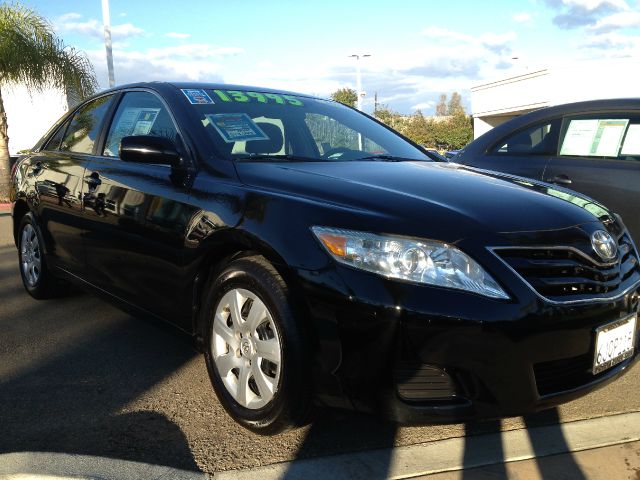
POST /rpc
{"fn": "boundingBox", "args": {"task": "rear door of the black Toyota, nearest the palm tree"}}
[27,95,113,275]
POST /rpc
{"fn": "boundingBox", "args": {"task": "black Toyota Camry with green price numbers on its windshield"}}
[12,83,640,433]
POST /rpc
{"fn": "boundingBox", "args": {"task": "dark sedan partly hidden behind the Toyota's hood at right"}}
[455,98,640,246]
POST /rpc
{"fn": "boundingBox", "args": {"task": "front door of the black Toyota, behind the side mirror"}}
[85,91,197,328]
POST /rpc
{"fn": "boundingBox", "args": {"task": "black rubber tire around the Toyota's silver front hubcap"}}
[202,256,312,434]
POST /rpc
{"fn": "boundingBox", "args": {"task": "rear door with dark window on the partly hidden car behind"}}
[463,119,560,180]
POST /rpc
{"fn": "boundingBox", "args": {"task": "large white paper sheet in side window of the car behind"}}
[560,119,629,157]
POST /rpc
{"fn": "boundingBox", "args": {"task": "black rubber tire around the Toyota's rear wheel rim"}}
[17,212,61,300]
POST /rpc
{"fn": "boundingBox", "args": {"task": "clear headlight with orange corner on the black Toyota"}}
[312,227,509,299]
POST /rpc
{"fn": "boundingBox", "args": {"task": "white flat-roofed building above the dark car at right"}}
[471,58,640,138]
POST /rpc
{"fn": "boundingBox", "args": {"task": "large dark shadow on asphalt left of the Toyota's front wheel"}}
[0,292,200,471]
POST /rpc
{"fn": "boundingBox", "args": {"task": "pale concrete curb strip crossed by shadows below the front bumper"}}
[214,412,640,480]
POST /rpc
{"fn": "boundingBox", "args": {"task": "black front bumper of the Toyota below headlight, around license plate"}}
[299,267,640,423]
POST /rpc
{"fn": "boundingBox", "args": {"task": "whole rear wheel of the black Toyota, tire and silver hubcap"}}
[18,212,59,299]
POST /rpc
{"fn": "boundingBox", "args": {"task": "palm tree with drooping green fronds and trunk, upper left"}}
[0,4,97,203]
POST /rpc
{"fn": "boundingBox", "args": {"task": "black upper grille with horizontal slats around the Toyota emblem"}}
[496,233,640,301]
